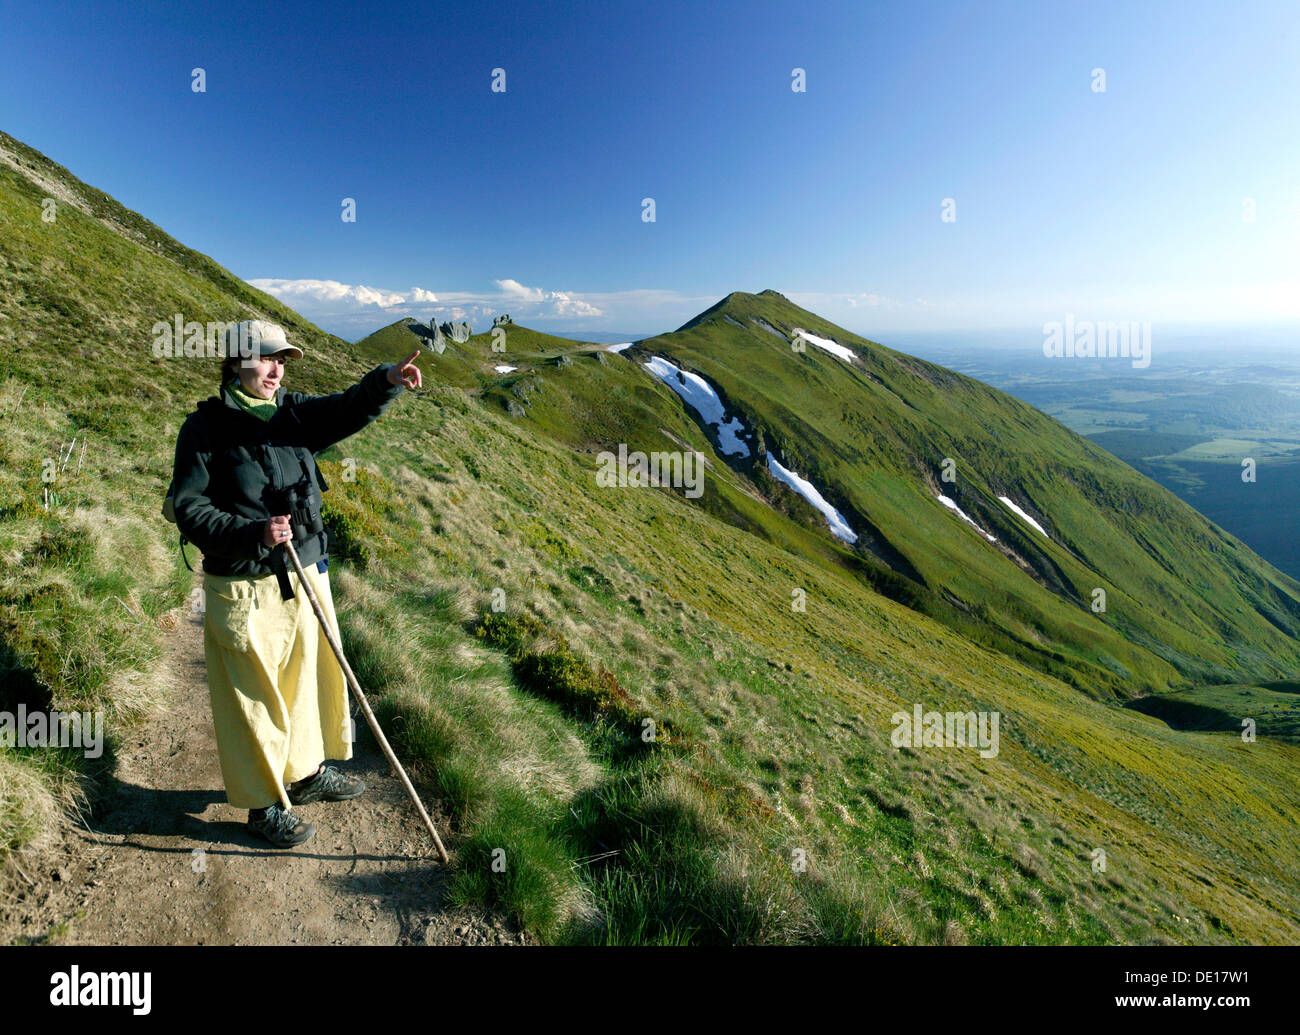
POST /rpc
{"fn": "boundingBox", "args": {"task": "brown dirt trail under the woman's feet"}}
[0,610,528,945]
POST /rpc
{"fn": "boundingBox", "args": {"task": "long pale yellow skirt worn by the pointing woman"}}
[203,564,352,809]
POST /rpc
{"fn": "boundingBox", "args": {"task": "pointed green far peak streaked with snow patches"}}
[625,291,1300,696]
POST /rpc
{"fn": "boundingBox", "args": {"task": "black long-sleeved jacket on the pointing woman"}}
[172,363,406,585]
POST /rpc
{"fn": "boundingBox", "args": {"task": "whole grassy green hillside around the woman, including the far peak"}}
[0,131,1300,944]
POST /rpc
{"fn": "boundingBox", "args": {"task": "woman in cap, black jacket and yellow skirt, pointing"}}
[172,320,423,848]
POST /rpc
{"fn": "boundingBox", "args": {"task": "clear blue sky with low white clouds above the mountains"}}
[0,0,1300,341]
